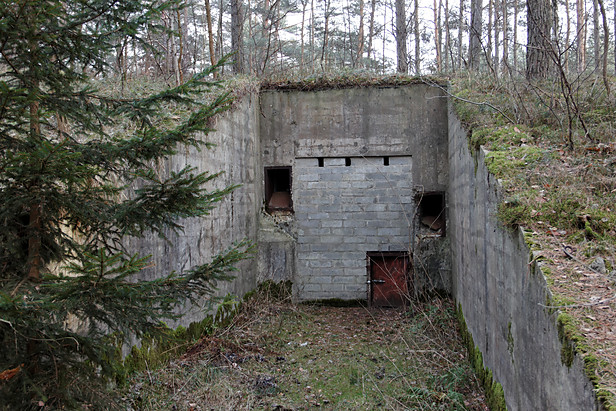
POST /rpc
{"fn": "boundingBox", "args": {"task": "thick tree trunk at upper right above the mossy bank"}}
[526,0,553,80]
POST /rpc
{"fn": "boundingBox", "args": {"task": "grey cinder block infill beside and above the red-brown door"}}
[293,156,414,300]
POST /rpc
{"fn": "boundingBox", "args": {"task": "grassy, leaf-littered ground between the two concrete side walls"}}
[123,296,488,410]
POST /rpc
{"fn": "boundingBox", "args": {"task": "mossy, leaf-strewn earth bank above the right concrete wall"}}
[451,76,616,407]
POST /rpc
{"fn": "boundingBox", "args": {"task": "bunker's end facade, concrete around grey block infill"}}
[260,85,451,305]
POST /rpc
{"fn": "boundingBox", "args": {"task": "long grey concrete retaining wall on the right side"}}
[448,104,597,411]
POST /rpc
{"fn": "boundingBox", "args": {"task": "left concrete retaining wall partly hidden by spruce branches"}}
[127,95,260,325]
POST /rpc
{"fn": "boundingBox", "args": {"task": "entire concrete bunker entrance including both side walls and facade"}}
[130,84,598,410]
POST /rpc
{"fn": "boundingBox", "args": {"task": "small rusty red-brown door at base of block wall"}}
[370,255,409,307]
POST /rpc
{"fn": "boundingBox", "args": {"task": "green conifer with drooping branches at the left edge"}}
[0,0,247,409]
